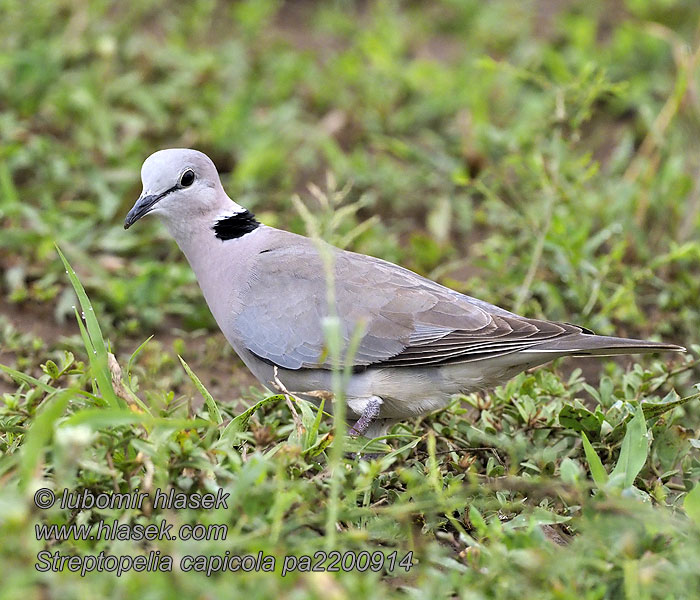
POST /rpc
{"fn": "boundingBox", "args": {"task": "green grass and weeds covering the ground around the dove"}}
[0,0,700,599]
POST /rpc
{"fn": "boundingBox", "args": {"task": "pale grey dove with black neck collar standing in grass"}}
[124,149,684,435]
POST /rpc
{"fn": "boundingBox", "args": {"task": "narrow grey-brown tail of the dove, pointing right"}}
[524,333,686,356]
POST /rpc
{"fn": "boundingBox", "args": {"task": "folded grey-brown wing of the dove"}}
[234,236,583,370]
